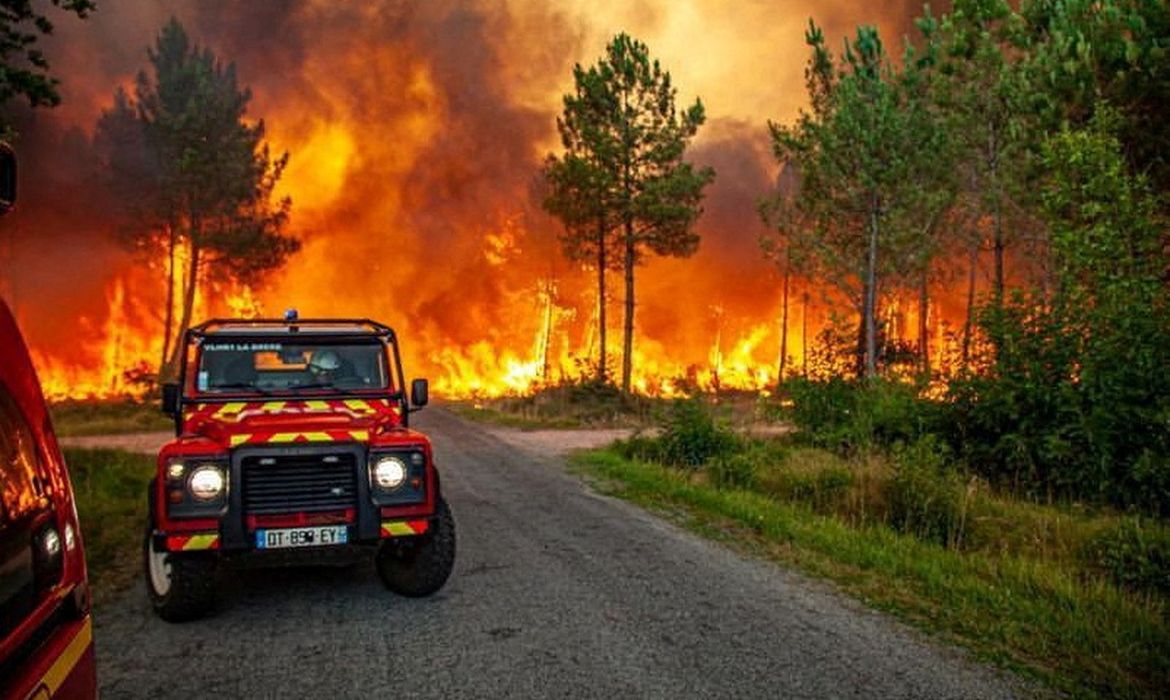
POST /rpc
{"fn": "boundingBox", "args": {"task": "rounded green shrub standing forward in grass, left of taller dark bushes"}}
[885,435,969,549]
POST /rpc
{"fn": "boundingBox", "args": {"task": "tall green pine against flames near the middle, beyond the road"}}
[548,34,715,392]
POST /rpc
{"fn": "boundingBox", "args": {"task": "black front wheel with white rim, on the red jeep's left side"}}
[143,527,219,623]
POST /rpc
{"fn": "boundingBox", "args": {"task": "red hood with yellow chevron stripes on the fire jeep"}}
[183,398,402,448]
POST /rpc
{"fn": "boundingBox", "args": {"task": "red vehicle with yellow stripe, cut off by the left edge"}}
[0,301,97,699]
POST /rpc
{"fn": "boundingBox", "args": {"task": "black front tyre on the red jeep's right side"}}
[374,499,455,598]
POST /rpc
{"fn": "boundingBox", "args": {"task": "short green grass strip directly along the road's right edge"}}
[573,448,1170,698]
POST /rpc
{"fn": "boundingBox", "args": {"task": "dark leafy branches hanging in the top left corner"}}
[0,0,95,127]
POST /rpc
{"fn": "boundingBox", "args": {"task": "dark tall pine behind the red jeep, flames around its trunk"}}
[95,19,300,375]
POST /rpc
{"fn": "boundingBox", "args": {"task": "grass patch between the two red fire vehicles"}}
[64,448,154,603]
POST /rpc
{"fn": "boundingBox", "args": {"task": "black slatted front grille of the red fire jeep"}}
[241,454,357,515]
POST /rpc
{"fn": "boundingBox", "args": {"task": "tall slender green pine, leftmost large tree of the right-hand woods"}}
[770,23,940,377]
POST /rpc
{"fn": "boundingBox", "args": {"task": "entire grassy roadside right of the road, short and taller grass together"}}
[572,442,1170,698]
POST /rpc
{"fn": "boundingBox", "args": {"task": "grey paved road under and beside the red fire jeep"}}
[96,409,1028,699]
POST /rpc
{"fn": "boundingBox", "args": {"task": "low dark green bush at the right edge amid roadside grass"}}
[1085,517,1170,596]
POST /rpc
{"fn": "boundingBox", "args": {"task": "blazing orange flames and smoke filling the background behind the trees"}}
[0,0,964,398]
